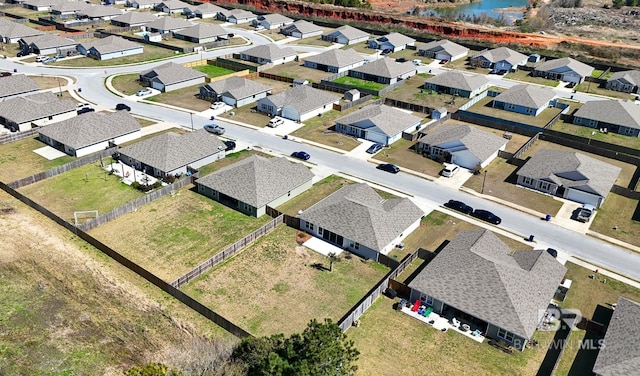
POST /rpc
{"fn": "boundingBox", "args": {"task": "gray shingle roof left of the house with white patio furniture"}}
[39,111,140,149]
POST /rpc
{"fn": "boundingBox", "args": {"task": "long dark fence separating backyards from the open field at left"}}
[0,182,251,338]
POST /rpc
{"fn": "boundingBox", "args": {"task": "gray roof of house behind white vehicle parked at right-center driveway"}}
[419,124,508,161]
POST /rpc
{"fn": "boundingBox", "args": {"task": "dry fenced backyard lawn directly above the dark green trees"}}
[183,225,388,335]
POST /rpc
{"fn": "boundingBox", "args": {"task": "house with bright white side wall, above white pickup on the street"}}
[258,85,340,121]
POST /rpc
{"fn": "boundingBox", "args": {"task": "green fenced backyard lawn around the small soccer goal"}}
[20,162,144,223]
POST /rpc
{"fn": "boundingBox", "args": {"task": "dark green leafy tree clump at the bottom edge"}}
[233,319,360,376]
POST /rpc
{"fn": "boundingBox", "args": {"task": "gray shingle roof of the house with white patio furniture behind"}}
[120,129,225,172]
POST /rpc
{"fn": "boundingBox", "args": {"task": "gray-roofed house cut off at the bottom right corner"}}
[593,296,640,376]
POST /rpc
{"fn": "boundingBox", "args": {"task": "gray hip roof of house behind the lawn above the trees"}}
[299,183,424,251]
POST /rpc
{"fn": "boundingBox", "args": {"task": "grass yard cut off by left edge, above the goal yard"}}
[0,137,75,183]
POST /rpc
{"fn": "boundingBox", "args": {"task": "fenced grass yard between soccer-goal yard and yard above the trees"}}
[91,188,270,282]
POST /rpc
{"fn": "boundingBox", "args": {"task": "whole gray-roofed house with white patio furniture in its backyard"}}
[118,128,226,178]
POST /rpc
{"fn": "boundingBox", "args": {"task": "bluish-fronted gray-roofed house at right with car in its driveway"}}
[516,150,621,208]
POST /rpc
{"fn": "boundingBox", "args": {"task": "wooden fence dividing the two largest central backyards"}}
[170,214,284,289]
